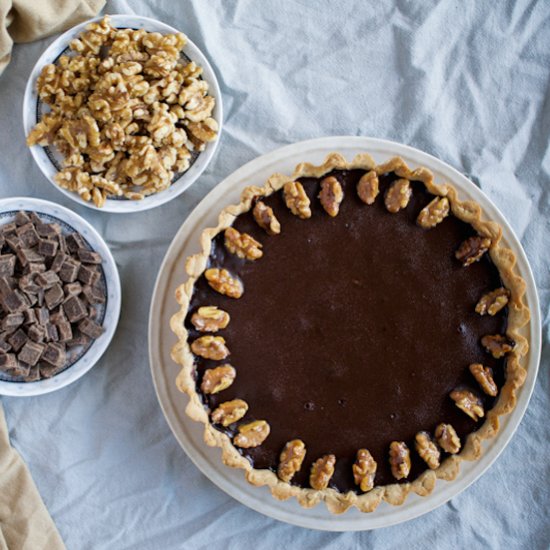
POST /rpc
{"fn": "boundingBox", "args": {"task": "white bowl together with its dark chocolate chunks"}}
[0,197,121,396]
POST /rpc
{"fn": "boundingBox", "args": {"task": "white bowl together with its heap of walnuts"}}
[23,15,223,213]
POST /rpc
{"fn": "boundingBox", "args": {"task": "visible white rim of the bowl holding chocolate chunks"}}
[0,197,121,396]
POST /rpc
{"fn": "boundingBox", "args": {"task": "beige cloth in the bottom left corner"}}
[0,403,65,550]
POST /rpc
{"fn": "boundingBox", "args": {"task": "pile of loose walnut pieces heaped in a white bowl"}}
[27,16,218,207]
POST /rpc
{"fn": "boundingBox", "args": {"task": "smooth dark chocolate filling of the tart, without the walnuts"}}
[186,170,507,491]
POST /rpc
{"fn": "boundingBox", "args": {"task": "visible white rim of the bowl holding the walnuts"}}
[23,15,223,213]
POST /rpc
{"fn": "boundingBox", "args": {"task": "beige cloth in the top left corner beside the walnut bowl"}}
[0,0,105,74]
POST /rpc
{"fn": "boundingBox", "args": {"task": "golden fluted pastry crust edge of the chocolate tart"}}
[170,153,530,514]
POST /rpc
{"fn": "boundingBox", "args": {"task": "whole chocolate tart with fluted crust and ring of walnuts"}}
[171,153,529,513]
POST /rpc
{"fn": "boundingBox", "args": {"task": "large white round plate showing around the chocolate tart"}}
[149,137,541,531]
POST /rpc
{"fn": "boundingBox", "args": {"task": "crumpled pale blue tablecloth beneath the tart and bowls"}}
[0,0,550,550]
